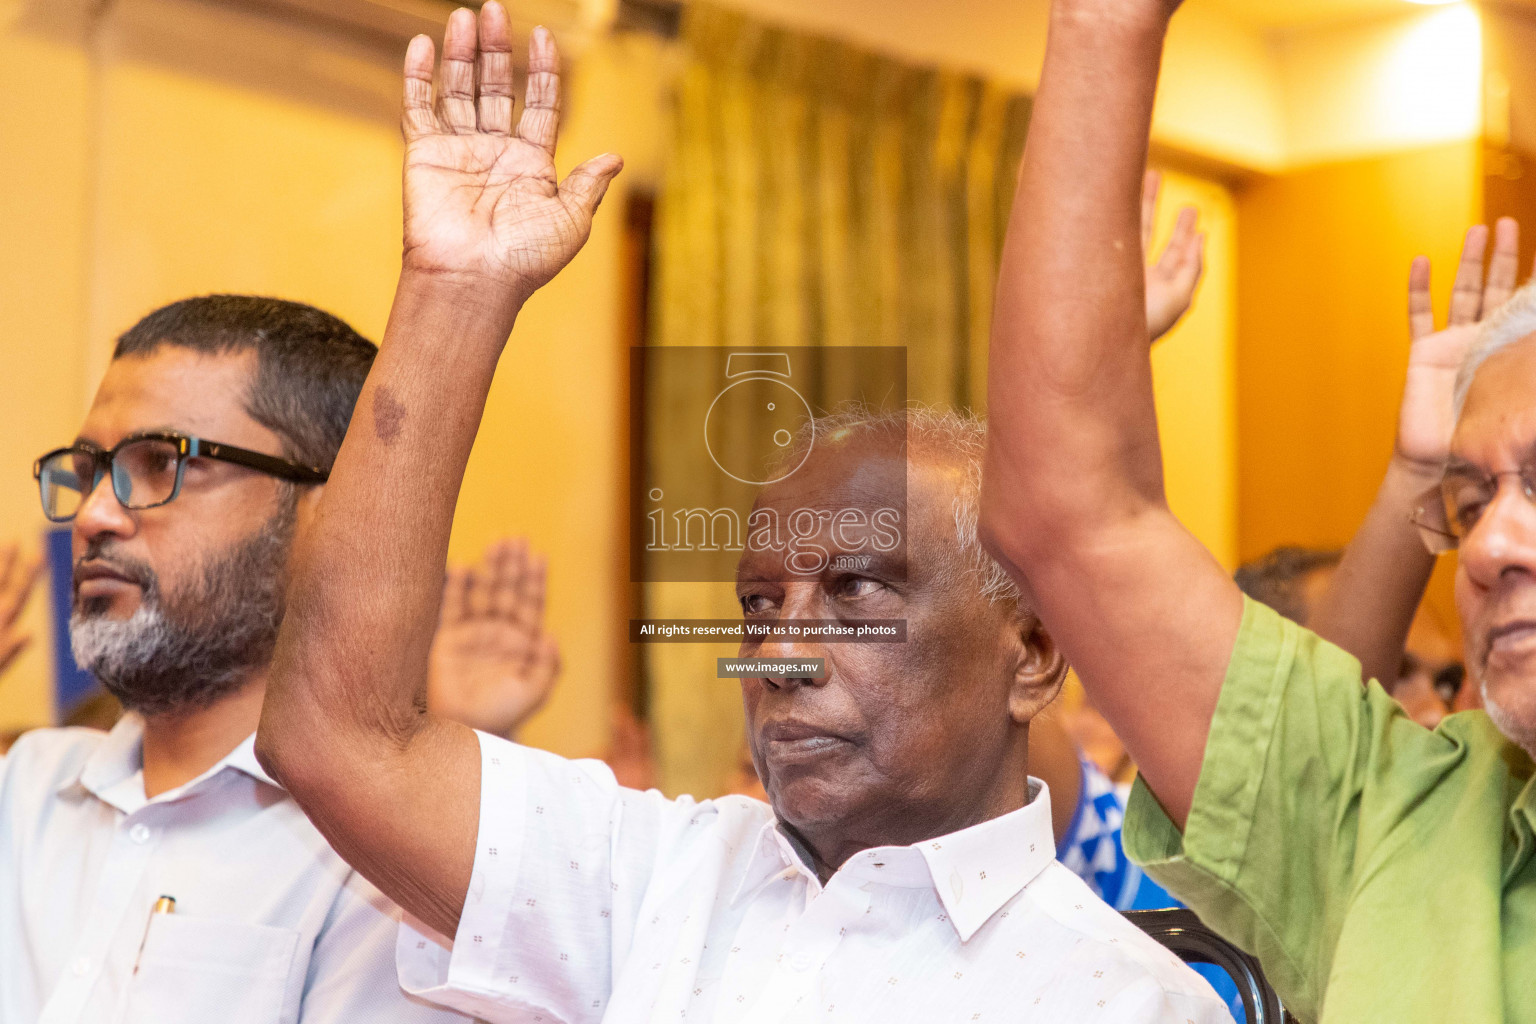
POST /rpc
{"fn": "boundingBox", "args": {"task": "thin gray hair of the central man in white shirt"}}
[782,405,1020,603]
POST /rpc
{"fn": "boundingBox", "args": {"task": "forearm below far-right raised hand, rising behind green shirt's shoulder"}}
[1307,457,1438,688]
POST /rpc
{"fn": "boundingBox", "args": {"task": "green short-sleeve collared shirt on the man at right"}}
[1124,602,1536,1024]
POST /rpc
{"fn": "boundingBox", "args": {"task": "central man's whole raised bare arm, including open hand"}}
[257,2,621,935]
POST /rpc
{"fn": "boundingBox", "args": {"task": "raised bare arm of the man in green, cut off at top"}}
[982,0,1241,826]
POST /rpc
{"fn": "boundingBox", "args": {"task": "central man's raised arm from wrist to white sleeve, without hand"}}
[258,273,516,935]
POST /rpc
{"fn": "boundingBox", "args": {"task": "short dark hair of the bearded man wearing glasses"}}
[112,295,378,470]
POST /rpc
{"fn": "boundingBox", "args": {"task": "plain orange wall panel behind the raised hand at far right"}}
[1238,141,1482,626]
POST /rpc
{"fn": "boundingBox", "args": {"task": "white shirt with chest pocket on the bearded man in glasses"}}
[0,715,464,1024]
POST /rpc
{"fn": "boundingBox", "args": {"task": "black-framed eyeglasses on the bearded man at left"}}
[32,430,327,522]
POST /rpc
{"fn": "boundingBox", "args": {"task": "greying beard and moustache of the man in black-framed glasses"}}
[69,496,298,717]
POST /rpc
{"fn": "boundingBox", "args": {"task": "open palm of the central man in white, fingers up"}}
[402,0,624,302]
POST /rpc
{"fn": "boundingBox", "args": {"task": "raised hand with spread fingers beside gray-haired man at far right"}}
[1396,218,1521,473]
